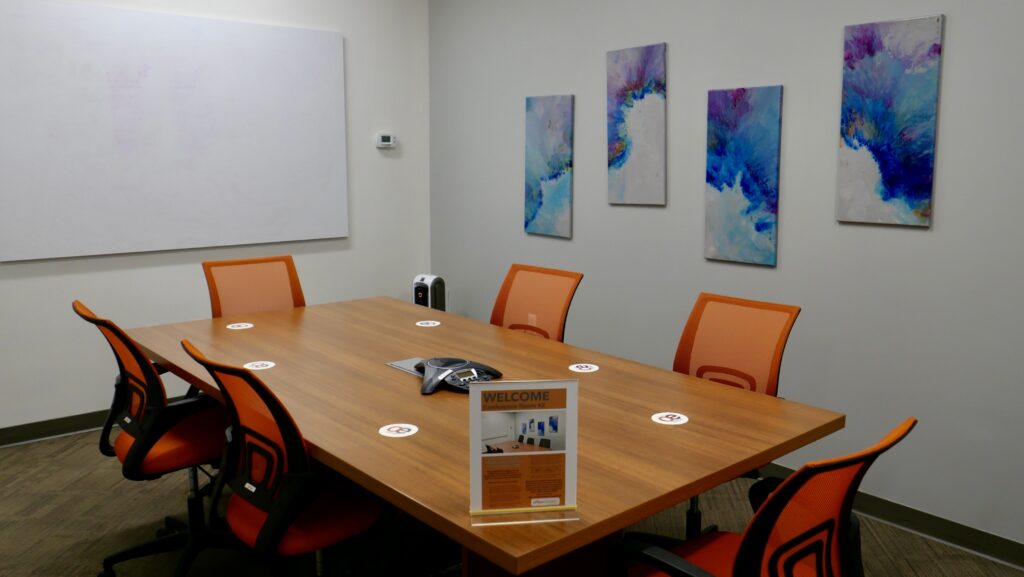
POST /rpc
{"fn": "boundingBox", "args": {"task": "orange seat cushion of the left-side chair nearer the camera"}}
[226,490,380,557]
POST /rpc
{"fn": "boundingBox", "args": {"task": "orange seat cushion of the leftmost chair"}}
[114,403,227,475]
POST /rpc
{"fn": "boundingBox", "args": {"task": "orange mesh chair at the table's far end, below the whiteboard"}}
[203,255,306,318]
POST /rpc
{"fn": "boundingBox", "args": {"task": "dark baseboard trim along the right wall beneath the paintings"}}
[761,463,1024,567]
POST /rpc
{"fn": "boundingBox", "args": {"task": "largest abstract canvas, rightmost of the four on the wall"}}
[836,15,943,226]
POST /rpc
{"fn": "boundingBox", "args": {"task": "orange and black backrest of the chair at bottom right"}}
[732,417,918,577]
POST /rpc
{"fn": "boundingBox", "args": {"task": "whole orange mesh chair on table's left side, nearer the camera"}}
[181,340,381,569]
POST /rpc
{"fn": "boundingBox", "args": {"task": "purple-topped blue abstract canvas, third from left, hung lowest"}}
[705,86,782,266]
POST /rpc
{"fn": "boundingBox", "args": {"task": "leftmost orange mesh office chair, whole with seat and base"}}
[72,300,227,576]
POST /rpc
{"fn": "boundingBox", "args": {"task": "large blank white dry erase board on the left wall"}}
[0,0,348,261]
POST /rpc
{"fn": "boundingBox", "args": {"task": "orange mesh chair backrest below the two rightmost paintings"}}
[673,292,800,397]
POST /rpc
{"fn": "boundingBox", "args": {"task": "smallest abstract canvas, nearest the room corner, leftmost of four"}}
[523,95,572,239]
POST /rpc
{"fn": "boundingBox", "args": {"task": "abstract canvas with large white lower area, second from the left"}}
[608,44,666,205]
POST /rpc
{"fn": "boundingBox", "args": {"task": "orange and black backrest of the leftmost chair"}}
[72,300,167,436]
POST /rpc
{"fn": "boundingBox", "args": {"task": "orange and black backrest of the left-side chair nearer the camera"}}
[181,340,310,511]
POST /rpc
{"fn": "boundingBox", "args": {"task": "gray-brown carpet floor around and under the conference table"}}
[0,431,1024,577]
